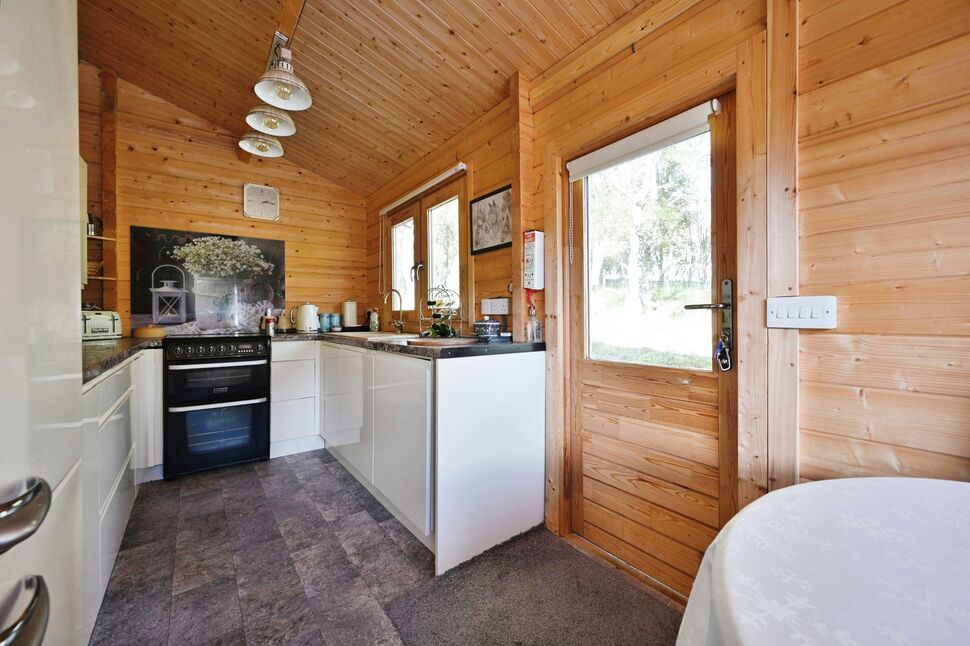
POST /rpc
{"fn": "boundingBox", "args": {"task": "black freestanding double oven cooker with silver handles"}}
[162,336,271,479]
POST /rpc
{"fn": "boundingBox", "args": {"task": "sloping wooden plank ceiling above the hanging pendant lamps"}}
[78,0,650,196]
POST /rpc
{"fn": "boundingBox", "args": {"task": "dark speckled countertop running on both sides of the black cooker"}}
[81,332,546,383]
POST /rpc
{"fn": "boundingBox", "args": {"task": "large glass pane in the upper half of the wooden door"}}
[583,120,714,370]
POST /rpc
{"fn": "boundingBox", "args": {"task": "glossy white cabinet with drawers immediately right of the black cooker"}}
[270,341,324,458]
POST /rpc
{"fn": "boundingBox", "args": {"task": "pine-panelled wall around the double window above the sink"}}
[367,99,515,334]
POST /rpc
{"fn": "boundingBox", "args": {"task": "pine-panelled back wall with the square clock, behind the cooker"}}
[81,61,367,330]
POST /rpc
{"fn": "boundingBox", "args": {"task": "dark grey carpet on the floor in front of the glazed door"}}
[386,528,681,646]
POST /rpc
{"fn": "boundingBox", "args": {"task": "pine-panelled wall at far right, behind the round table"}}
[799,0,970,480]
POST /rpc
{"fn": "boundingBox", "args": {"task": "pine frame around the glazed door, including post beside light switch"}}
[542,29,798,548]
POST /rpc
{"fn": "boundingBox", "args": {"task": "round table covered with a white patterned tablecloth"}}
[677,478,970,646]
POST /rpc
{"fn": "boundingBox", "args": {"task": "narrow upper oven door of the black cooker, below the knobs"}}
[165,359,269,406]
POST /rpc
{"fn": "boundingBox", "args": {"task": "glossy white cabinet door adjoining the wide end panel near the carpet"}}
[373,354,433,536]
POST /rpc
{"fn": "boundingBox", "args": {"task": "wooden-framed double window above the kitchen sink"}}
[384,178,470,331]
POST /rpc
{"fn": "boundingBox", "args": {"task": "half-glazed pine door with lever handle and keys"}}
[564,94,737,596]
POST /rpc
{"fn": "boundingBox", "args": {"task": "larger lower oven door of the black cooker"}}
[163,397,269,478]
